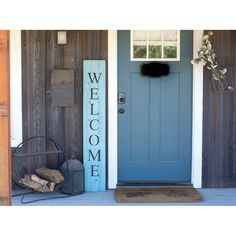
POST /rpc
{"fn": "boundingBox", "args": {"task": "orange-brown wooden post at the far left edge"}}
[0,30,11,206]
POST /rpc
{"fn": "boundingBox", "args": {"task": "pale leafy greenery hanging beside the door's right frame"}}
[191,31,234,92]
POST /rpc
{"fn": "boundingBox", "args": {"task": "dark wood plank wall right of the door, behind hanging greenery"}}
[202,30,236,188]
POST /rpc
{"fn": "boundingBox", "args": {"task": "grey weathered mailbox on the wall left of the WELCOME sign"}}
[51,69,75,107]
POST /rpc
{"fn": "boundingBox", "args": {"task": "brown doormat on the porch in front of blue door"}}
[115,187,202,203]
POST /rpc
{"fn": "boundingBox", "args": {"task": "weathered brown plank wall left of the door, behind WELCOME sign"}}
[22,30,108,174]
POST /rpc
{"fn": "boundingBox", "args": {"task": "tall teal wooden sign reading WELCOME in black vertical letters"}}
[83,60,106,192]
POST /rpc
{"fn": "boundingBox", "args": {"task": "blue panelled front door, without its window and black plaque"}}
[118,31,193,182]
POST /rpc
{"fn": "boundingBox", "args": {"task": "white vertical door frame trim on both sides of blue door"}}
[108,30,203,189]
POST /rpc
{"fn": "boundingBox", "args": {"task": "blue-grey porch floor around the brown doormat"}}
[12,188,236,206]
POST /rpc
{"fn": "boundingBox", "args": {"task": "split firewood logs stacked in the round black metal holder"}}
[19,167,64,193]
